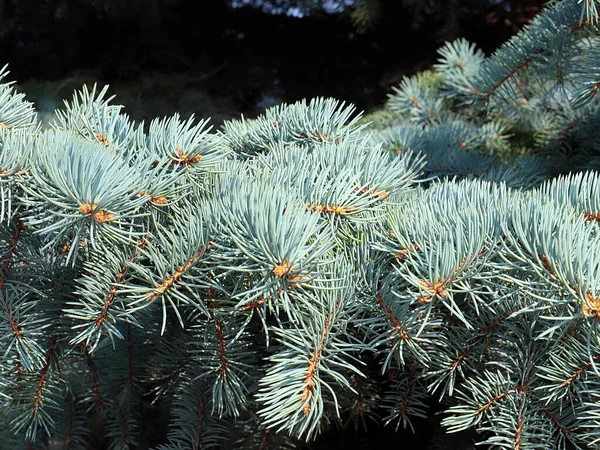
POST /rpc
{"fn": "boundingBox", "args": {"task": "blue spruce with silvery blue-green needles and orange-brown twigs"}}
[0,0,600,450]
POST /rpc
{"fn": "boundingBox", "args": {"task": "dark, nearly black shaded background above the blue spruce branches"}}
[0,0,544,122]
